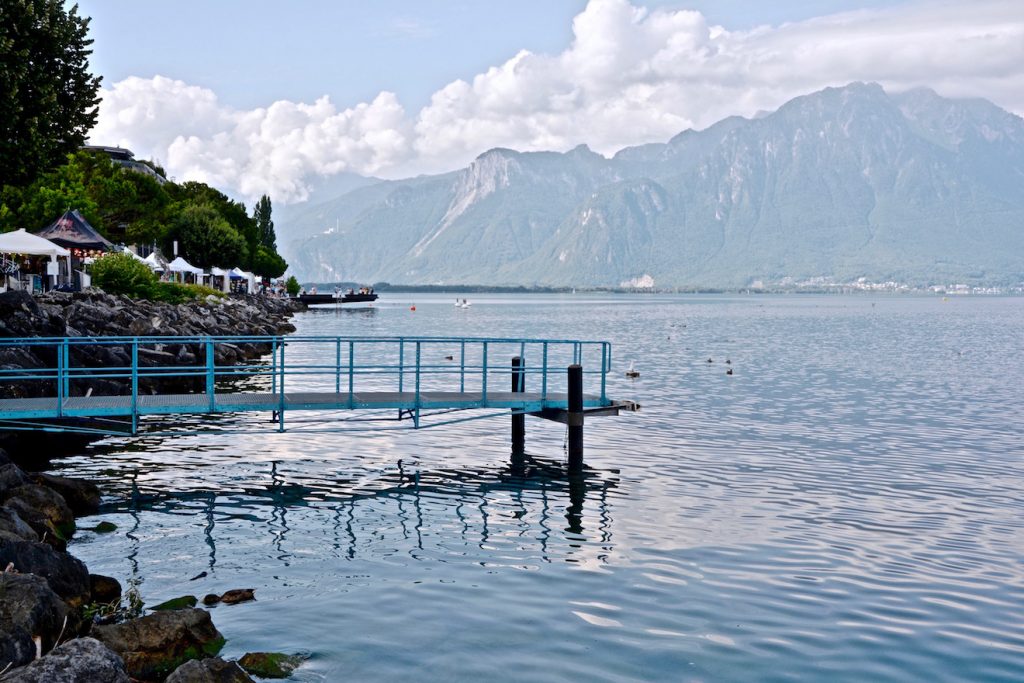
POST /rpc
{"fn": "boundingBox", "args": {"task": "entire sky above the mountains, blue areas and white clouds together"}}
[78,0,1024,203]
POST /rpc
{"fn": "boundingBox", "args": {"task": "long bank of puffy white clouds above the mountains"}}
[91,0,1024,202]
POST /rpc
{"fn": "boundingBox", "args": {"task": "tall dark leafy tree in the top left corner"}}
[0,0,100,186]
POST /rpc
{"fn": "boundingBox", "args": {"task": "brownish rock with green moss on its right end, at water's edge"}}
[92,609,224,681]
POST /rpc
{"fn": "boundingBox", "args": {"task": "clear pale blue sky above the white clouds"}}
[79,0,906,108]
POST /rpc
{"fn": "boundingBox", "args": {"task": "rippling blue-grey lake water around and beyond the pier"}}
[56,294,1024,681]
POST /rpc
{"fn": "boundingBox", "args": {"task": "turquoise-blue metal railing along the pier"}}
[0,336,611,432]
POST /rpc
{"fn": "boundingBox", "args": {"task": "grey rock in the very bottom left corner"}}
[3,638,131,683]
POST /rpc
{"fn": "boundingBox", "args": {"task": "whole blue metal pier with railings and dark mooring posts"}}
[0,336,638,469]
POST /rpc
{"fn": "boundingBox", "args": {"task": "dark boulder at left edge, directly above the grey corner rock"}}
[0,573,71,667]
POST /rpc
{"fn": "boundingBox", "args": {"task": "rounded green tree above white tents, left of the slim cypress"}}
[162,204,248,268]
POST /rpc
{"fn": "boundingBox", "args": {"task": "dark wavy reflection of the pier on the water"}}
[103,456,617,570]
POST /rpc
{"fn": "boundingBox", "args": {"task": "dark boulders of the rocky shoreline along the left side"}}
[0,291,304,683]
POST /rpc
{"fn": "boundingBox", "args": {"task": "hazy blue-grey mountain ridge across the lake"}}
[279,83,1024,288]
